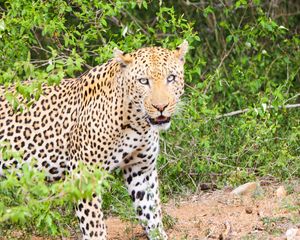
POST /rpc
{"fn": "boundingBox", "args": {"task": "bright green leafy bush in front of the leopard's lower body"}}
[0,156,109,236]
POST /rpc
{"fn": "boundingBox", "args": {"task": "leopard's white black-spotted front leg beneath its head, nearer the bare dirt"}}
[123,153,167,240]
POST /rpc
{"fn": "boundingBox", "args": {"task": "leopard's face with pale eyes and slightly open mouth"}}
[118,41,188,129]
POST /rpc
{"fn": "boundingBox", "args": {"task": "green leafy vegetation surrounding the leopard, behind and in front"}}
[0,0,300,236]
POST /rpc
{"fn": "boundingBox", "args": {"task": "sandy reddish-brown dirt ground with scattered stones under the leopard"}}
[0,181,300,240]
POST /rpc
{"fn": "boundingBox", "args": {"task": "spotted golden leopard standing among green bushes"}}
[0,40,188,240]
